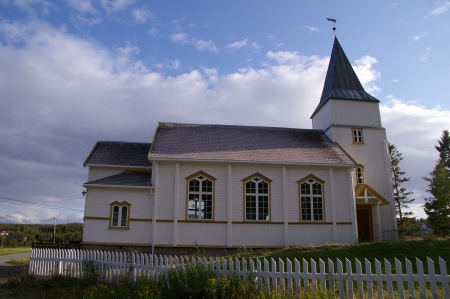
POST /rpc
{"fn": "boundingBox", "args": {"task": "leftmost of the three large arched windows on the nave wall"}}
[186,171,216,220]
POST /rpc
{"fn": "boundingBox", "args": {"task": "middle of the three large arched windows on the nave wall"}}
[244,174,271,221]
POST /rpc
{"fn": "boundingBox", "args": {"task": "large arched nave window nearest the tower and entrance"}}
[299,175,325,221]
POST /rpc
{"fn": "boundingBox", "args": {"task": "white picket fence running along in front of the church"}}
[29,249,450,298]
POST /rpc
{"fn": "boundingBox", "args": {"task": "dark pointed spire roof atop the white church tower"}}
[311,37,379,118]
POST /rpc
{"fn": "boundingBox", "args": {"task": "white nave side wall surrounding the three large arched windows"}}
[151,162,356,247]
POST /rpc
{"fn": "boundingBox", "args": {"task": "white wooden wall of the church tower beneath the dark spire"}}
[312,99,397,240]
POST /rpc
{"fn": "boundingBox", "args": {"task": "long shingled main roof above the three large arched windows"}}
[149,123,356,166]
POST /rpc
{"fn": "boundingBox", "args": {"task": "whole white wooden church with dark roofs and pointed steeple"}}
[82,38,397,248]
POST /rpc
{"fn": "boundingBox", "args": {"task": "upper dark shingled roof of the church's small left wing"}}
[83,141,151,167]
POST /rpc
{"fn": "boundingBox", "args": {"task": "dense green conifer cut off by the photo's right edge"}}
[424,130,450,236]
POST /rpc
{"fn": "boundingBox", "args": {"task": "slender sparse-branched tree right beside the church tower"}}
[389,143,415,229]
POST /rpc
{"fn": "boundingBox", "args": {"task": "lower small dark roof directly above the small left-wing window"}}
[83,170,152,187]
